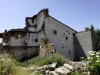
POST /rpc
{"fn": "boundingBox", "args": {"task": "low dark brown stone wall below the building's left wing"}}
[8,46,39,61]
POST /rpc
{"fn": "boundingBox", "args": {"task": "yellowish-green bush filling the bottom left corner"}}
[0,54,30,75]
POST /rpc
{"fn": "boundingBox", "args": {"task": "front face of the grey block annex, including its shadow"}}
[74,31,93,59]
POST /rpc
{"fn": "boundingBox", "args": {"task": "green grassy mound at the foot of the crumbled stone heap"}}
[22,53,68,66]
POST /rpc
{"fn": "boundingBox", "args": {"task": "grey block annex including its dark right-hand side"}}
[74,31,100,59]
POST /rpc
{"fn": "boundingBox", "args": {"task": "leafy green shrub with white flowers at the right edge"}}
[87,51,100,75]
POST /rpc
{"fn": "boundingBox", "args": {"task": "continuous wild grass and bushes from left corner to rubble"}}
[0,54,67,75]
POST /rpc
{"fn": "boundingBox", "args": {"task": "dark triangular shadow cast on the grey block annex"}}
[74,35,87,61]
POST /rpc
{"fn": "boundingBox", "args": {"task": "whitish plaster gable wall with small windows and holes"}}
[45,16,76,59]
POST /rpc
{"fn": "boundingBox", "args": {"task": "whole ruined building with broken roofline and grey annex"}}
[2,9,100,60]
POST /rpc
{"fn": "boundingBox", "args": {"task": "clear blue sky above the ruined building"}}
[0,0,100,32]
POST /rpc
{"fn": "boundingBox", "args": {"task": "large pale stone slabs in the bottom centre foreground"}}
[37,63,74,75]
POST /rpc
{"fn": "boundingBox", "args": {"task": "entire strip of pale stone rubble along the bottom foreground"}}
[37,62,89,75]
